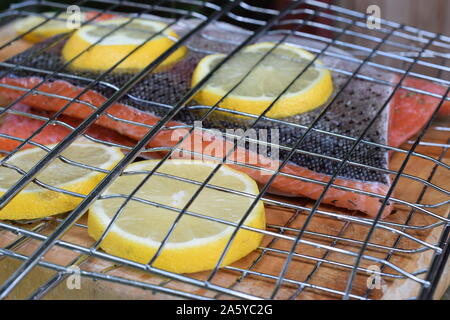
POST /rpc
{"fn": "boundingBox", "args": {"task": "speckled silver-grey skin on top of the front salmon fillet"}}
[0,21,391,185]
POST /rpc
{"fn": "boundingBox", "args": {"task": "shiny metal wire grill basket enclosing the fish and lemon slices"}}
[0,0,450,299]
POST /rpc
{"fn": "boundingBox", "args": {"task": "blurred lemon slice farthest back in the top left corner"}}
[14,11,113,42]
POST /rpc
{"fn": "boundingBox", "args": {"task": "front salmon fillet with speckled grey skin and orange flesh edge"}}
[0,17,442,217]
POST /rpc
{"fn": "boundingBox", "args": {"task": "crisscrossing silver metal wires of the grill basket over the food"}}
[0,0,450,299]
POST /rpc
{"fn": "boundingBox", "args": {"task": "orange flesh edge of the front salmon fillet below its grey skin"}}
[0,77,392,217]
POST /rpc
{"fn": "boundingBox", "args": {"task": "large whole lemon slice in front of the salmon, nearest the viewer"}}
[88,160,265,273]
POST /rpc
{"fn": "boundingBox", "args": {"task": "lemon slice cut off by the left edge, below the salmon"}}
[0,142,123,220]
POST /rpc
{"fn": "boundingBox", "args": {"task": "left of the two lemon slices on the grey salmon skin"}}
[62,18,186,72]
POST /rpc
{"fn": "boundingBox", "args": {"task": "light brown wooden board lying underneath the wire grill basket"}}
[0,21,450,299]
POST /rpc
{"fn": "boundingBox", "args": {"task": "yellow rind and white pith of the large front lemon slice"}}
[88,159,265,273]
